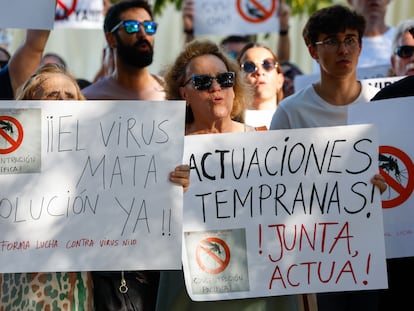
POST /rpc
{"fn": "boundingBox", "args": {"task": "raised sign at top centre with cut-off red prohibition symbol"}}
[194,0,280,35]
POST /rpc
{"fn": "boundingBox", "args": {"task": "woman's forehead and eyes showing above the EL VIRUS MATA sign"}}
[33,73,80,100]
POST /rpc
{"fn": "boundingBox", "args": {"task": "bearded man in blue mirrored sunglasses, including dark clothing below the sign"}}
[82,0,165,311]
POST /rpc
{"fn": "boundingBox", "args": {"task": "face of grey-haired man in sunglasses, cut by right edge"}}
[391,31,414,76]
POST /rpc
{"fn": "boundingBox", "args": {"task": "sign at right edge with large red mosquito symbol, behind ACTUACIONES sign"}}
[349,97,414,258]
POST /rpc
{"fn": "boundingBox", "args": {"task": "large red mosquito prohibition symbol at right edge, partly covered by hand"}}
[379,146,414,208]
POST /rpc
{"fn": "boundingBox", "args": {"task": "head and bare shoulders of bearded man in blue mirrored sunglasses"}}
[82,0,165,100]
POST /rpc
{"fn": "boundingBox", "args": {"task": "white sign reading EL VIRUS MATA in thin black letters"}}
[0,101,185,272]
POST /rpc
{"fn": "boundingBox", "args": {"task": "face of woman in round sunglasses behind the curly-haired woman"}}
[240,47,283,100]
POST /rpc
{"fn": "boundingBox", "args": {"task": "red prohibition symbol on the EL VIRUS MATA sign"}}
[0,116,23,154]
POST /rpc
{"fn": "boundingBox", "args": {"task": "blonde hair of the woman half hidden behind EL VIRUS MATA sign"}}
[16,63,86,100]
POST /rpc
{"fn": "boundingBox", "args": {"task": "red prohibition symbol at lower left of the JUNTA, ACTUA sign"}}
[196,237,230,274]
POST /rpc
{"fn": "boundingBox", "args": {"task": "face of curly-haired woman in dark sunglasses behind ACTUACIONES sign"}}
[180,54,235,127]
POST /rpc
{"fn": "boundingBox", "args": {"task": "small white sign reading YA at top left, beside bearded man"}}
[55,0,104,29]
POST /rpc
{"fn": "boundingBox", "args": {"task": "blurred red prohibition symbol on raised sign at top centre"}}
[237,0,277,23]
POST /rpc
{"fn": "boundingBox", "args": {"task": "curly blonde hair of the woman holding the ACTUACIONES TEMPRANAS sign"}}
[165,40,253,123]
